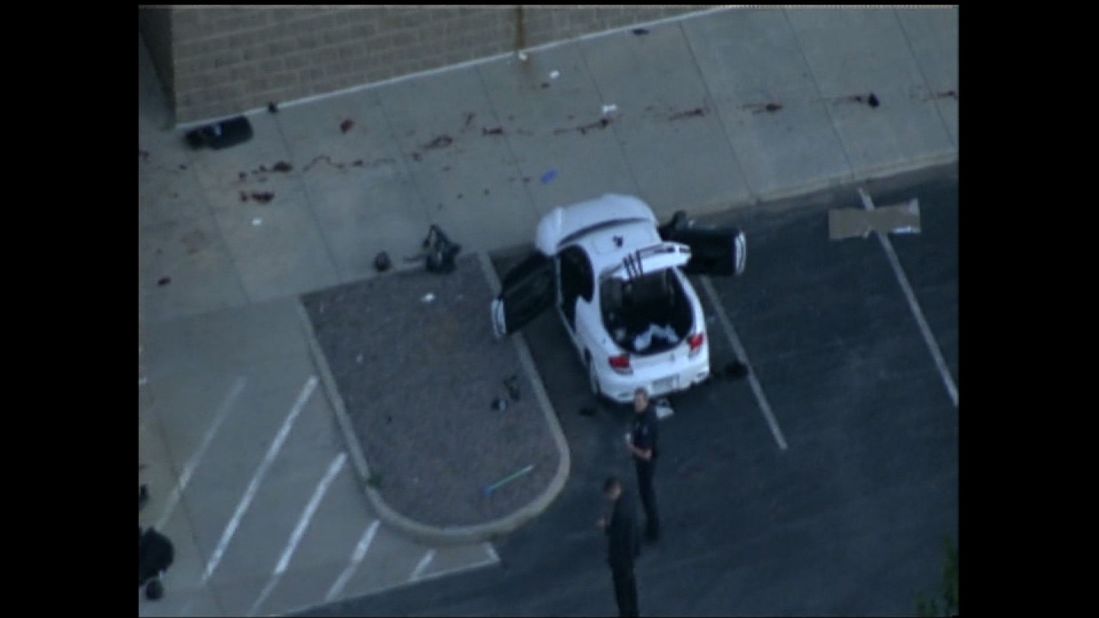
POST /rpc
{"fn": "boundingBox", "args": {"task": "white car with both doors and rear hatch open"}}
[491,194,746,404]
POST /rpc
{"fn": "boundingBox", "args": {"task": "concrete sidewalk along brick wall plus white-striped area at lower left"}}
[138,9,958,614]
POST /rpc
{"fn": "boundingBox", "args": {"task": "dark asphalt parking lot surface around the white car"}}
[311,168,959,616]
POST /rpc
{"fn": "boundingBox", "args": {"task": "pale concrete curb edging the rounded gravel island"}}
[298,253,571,545]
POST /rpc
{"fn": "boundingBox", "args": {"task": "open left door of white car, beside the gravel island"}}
[492,252,557,338]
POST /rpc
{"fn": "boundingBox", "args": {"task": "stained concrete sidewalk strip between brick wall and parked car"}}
[138,9,958,321]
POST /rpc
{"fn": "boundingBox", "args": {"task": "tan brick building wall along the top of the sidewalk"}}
[145,5,707,123]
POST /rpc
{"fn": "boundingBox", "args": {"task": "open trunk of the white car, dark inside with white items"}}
[600,268,695,356]
